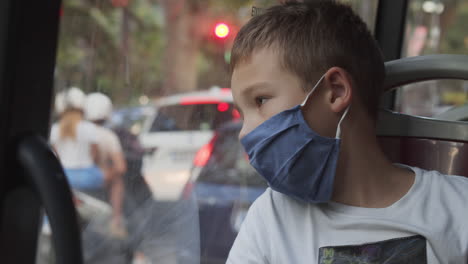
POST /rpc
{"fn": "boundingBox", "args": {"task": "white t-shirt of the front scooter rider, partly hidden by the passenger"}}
[96,127,122,166]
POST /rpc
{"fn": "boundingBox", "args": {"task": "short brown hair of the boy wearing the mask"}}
[231,0,385,120]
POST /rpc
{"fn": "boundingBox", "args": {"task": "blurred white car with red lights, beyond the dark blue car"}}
[140,88,239,200]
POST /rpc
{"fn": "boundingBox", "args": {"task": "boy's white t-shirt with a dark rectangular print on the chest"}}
[227,168,468,264]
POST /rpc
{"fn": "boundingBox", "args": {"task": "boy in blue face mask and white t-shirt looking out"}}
[227,1,468,264]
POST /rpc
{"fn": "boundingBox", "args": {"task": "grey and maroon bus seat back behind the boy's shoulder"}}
[377,55,468,177]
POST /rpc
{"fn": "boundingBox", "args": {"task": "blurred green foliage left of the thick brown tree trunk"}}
[56,0,164,105]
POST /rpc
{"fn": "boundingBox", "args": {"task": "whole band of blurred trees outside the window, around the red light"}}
[56,0,278,104]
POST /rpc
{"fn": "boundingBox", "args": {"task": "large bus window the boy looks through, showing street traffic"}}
[38,0,378,264]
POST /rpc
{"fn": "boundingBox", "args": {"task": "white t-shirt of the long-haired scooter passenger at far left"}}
[50,121,98,169]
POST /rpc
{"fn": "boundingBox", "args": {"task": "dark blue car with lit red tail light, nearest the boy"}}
[183,122,267,263]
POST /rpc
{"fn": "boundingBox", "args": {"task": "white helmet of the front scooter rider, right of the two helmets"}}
[84,93,112,121]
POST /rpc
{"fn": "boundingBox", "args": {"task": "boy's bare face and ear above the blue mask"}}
[231,48,342,138]
